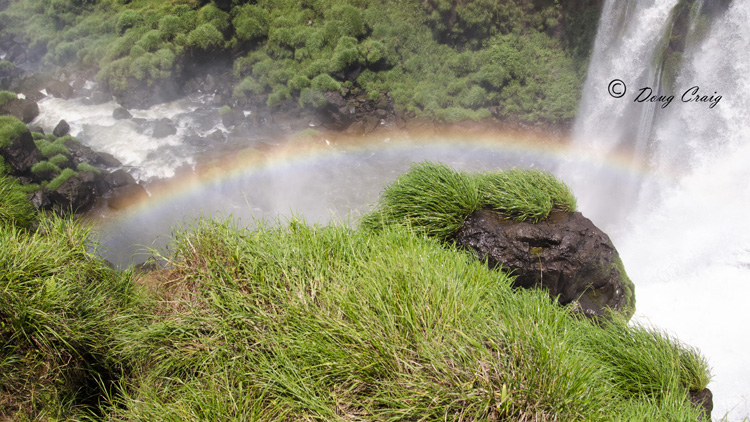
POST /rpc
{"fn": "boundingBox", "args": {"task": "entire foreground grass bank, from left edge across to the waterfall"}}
[0,166,709,422]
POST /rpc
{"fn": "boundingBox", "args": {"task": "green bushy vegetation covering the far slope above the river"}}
[0,0,600,124]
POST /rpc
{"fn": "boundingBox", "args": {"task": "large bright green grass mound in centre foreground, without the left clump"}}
[102,216,705,421]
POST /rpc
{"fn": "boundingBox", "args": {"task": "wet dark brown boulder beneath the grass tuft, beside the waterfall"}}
[456,210,635,318]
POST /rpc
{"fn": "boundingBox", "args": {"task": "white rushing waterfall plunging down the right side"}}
[561,0,750,420]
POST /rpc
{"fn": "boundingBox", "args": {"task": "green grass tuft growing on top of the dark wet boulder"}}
[362,162,576,240]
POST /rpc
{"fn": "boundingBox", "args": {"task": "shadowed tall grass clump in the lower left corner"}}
[0,204,140,420]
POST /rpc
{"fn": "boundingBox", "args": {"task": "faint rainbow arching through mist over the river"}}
[94,128,650,231]
